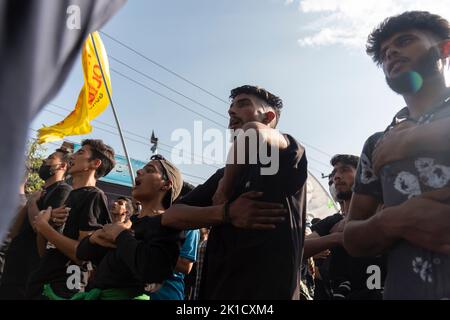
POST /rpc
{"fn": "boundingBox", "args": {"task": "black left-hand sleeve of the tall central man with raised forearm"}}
[177,168,225,207]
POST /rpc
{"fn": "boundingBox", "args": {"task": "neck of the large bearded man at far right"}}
[403,76,449,119]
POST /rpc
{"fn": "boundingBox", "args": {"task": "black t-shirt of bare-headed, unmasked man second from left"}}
[27,187,111,298]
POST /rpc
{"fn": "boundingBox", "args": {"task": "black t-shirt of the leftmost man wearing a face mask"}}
[0,181,72,299]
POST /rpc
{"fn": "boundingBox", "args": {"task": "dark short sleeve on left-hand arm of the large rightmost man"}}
[353,132,383,202]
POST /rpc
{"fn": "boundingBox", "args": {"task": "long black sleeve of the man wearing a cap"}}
[116,215,181,283]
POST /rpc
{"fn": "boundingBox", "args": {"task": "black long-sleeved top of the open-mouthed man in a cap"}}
[77,215,182,292]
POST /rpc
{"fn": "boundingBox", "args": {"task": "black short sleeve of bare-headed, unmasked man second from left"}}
[78,191,111,231]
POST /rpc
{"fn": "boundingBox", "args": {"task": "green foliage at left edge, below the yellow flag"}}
[25,139,46,194]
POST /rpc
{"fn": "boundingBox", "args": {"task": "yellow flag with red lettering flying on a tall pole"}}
[38,32,112,143]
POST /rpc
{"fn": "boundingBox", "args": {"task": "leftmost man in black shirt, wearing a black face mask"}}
[0,149,72,300]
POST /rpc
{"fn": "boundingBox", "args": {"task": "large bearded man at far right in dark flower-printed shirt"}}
[344,11,450,299]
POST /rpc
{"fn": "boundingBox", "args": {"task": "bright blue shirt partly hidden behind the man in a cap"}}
[150,230,200,300]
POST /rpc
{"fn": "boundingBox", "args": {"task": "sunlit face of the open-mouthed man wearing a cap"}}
[132,160,166,201]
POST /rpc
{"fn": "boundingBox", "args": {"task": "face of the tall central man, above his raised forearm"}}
[228,94,267,130]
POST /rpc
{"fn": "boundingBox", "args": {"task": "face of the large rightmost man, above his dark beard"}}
[380,29,438,79]
